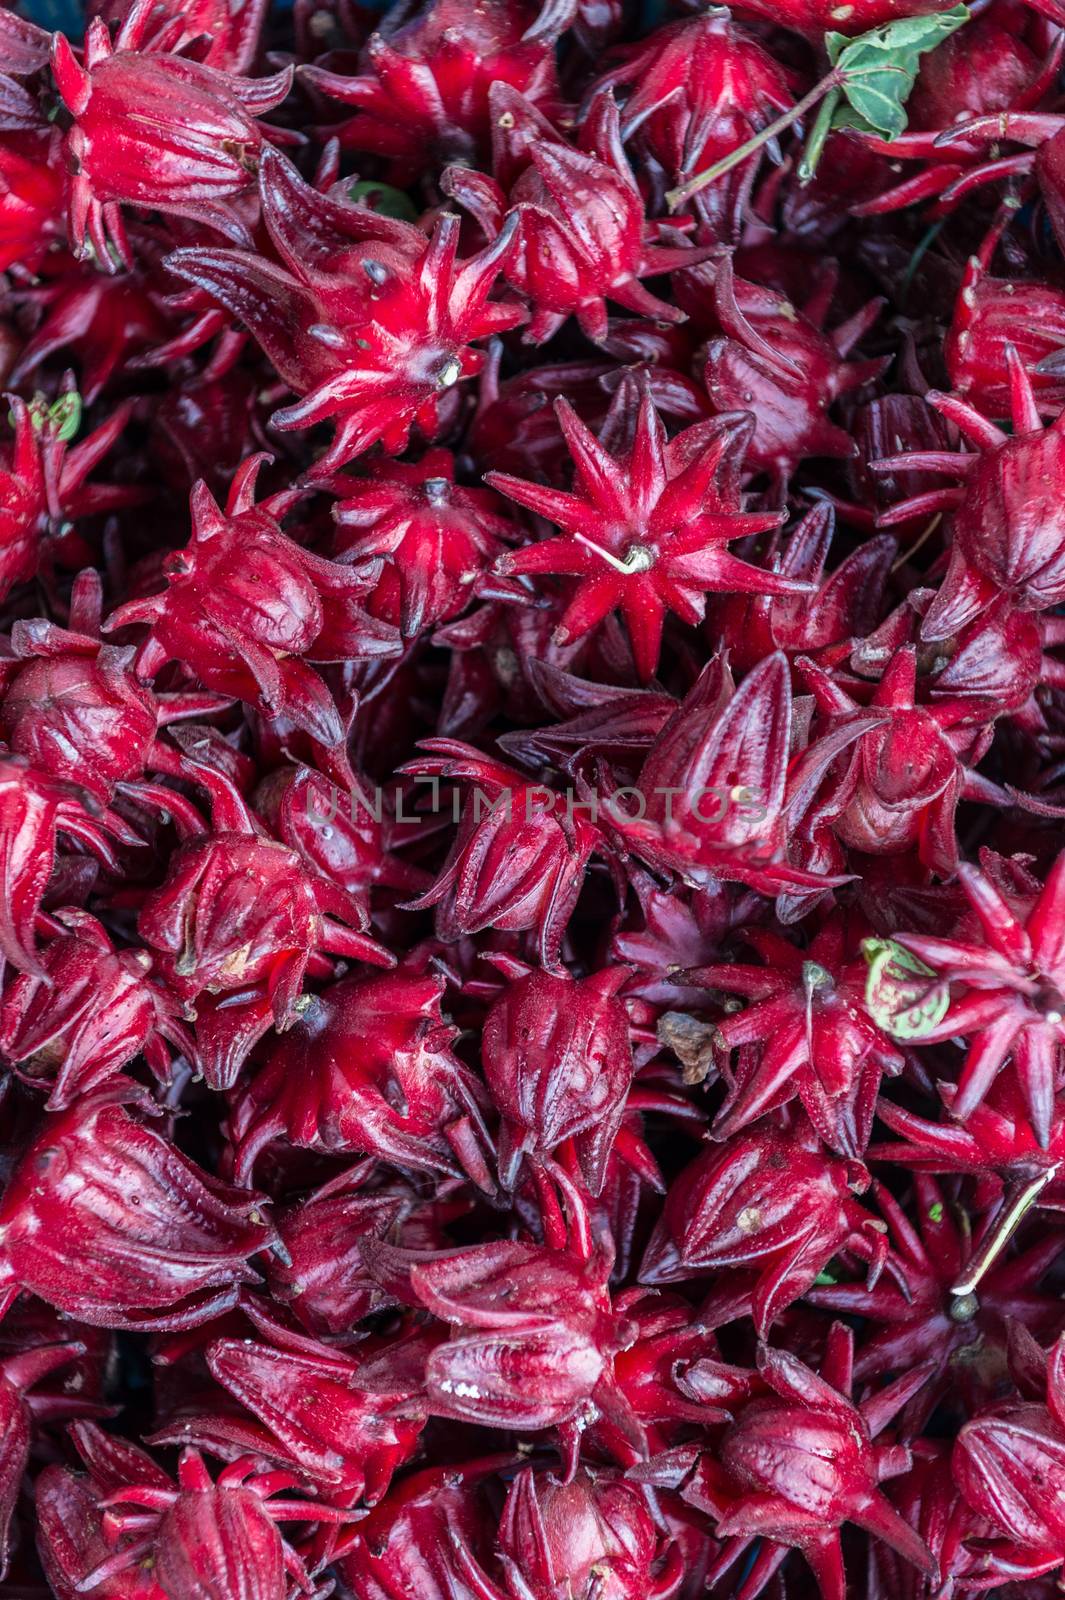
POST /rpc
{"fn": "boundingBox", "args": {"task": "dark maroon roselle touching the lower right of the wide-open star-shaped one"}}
[708,502,895,670]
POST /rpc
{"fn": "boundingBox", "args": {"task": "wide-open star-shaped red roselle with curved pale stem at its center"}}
[488,386,793,682]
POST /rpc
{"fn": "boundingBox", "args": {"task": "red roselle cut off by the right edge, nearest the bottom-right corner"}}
[951,1339,1065,1578]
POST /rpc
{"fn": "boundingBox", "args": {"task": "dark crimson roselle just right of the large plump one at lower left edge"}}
[267,1160,450,1339]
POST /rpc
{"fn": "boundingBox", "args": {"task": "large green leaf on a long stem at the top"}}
[825,5,969,139]
